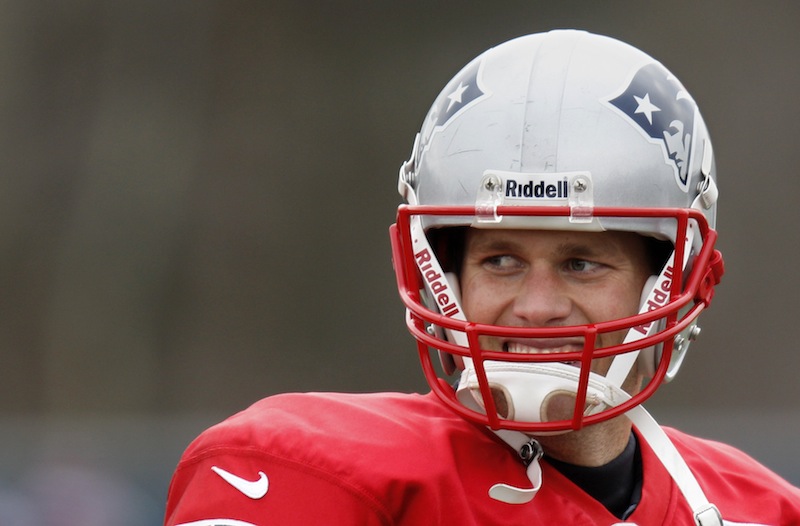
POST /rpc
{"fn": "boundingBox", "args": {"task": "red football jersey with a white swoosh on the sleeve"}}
[165,393,800,526]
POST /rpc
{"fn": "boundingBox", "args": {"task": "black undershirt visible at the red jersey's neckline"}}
[545,433,642,519]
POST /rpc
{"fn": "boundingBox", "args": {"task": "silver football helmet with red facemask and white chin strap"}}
[391,30,723,433]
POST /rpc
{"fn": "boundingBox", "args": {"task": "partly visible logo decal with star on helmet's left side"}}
[421,60,487,150]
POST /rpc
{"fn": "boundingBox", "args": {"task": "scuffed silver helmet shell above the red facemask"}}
[401,30,716,238]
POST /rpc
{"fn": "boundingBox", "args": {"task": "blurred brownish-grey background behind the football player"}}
[0,0,800,526]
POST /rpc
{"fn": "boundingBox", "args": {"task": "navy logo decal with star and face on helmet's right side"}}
[609,64,697,191]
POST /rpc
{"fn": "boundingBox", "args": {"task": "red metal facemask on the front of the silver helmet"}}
[391,205,722,432]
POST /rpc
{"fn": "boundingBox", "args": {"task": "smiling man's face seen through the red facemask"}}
[460,229,652,380]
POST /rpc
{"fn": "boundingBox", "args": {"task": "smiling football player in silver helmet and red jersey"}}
[166,31,800,526]
